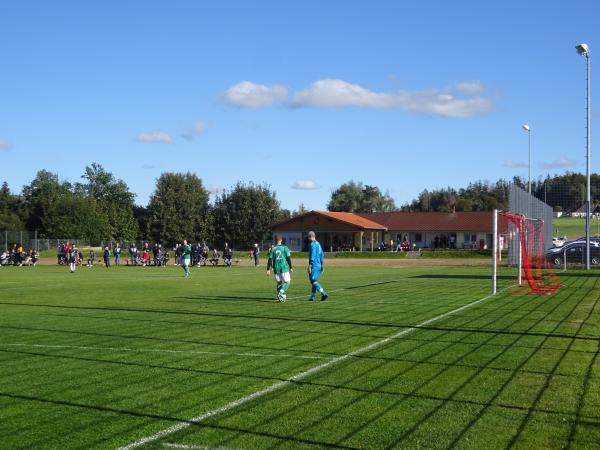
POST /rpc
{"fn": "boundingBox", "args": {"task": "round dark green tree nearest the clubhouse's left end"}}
[214,183,281,248]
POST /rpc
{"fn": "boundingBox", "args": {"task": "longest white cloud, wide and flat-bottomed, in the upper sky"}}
[292,79,493,117]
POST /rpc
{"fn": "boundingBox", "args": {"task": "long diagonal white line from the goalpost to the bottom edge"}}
[118,288,508,450]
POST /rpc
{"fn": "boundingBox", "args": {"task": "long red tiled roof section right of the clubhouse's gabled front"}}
[357,211,506,232]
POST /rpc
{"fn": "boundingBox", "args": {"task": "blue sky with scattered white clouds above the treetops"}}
[0,0,600,209]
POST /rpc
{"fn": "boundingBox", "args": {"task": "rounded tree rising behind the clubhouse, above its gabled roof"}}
[327,181,396,212]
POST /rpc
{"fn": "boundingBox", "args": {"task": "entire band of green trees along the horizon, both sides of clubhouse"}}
[0,168,600,248]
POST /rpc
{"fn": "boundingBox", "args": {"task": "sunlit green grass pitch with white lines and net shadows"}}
[0,266,600,449]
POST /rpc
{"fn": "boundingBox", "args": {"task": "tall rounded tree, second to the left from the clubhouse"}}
[148,172,212,244]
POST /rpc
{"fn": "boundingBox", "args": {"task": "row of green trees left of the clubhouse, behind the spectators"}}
[0,163,290,248]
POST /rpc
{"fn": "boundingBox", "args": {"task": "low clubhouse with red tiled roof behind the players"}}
[272,211,507,251]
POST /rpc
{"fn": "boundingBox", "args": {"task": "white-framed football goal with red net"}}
[492,209,561,294]
